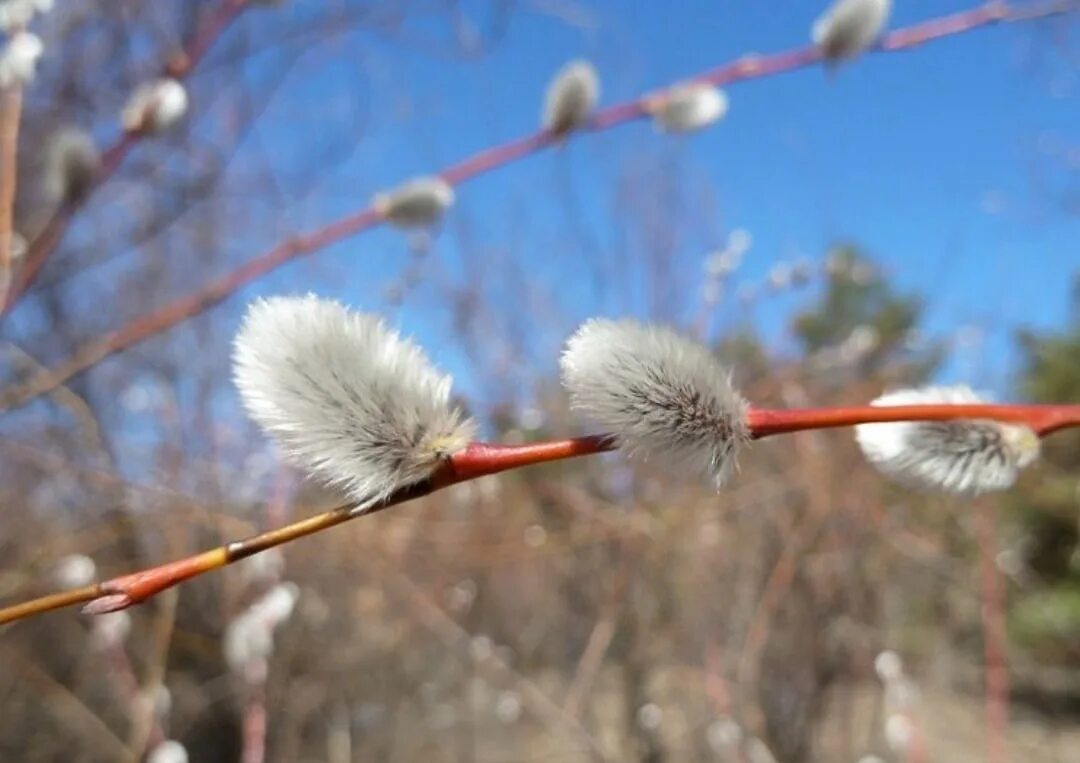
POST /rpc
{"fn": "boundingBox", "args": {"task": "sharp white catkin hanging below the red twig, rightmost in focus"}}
[855,386,1039,495]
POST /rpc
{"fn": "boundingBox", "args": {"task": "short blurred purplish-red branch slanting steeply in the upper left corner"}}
[0,0,247,318]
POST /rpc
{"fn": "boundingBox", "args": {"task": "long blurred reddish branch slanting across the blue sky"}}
[0,0,1067,411]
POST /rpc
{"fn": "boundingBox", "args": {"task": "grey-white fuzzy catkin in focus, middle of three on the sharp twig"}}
[562,319,748,486]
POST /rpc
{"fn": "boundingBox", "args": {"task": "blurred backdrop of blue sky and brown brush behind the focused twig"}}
[0,0,1080,763]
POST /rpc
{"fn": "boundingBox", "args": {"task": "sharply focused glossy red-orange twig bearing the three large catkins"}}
[0,397,1080,625]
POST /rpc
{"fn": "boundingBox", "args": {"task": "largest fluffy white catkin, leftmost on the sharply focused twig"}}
[233,295,474,507]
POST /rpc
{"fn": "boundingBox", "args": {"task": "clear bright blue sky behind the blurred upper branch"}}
[230,0,1080,404]
